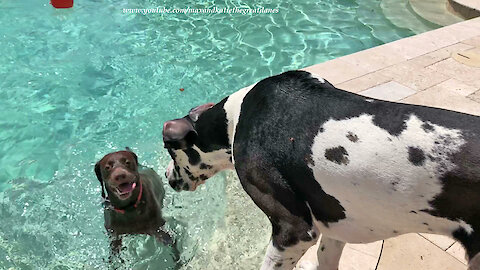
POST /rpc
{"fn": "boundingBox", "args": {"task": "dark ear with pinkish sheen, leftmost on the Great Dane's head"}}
[162,118,198,149]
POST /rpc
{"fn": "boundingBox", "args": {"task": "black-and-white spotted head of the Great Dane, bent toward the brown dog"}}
[163,103,232,191]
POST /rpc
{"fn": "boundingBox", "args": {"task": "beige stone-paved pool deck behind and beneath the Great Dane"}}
[297,18,480,270]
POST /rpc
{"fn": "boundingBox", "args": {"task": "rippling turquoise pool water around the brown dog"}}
[0,0,436,269]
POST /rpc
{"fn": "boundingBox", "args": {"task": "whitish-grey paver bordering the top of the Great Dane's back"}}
[359,82,416,101]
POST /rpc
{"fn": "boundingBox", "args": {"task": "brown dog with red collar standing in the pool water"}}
[95,148,179,260]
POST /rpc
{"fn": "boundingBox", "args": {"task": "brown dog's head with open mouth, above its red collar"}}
[95,151,140,201]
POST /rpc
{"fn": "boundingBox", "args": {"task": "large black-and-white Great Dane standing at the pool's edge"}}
[163,71,480,270]
